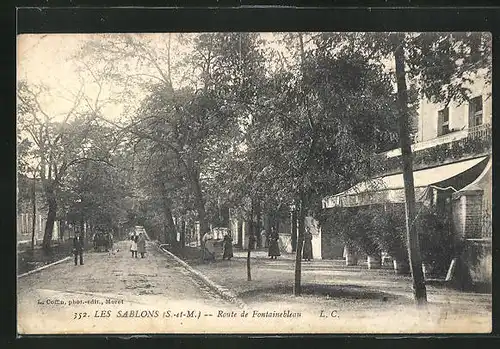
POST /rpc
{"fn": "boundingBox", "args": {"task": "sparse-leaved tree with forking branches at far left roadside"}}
[17,66,120,251]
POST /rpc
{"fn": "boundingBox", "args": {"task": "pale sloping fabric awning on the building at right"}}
[322,156,488,208]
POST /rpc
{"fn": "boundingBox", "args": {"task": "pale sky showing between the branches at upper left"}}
[17,33,398,128]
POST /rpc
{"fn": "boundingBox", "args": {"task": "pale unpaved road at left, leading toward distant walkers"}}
[17,241,235,334]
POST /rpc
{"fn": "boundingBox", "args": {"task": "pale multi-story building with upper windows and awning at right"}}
[321,72,492,281]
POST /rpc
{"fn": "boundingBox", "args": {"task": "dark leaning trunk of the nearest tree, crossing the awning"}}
[393,35,427,304]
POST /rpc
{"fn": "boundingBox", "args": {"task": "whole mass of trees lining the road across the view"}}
[19,33,491,300]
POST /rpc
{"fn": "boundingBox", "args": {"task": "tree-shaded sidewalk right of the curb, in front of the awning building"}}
[170,245,492,333]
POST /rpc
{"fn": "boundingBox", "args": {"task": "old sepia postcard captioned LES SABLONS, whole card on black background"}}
[17,32,492,335]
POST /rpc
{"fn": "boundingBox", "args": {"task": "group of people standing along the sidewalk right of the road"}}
[202,228,313,262]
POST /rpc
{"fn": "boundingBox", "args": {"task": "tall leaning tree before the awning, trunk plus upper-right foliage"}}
[352,33,491,304]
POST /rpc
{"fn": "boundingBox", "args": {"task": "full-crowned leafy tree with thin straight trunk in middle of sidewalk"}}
[220,34,402,295]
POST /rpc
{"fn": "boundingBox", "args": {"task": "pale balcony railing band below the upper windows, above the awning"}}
[381,124,491,158]
